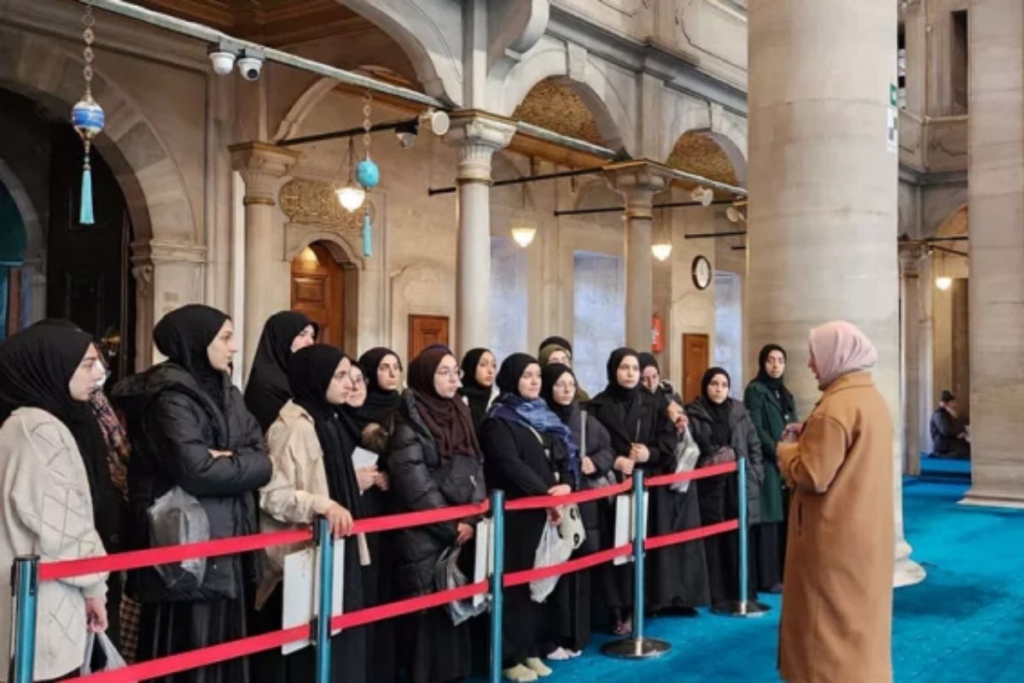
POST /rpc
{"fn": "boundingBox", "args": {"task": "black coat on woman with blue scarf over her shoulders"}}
[480,417,571,572]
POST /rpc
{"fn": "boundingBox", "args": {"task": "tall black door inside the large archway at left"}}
[46,124,135,381]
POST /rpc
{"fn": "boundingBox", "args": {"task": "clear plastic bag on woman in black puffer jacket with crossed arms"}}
[146,486,210,592]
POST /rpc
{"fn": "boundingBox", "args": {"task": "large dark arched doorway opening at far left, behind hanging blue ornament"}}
[0,89,135,379]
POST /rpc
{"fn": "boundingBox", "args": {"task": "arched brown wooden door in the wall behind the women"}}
[291,242,356,348]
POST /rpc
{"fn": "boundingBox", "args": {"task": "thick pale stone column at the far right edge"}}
[965,0,1024,507]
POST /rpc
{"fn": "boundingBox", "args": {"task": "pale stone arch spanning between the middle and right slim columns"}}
[497,37,636,152]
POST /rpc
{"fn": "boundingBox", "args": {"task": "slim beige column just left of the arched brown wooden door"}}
[228,142,301,377]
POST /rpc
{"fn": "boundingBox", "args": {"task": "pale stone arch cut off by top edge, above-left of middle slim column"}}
[344,0,463,105]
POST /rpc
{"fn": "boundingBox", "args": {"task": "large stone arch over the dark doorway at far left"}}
[0,28,200,243]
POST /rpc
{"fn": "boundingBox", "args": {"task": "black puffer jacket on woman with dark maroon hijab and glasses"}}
[385,391,486,598]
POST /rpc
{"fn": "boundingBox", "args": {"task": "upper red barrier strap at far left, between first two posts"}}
[39,528,313,581]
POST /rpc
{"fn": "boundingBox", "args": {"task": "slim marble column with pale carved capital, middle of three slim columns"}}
[447,112,515,357]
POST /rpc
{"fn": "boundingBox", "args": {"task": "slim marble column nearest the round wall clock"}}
[605,162,669,351]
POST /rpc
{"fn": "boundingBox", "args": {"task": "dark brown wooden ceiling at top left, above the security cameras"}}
[136,0,368,47]
